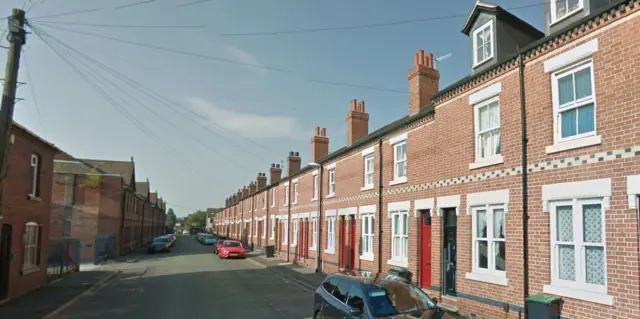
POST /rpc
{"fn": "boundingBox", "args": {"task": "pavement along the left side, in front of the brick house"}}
[0,250,142,319]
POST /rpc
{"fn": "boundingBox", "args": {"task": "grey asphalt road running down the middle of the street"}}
[61,235,313,319]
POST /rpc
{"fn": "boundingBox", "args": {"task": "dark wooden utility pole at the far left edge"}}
[0,9,26,219]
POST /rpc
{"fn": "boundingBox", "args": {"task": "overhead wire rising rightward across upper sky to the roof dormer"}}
[221,2,545,37]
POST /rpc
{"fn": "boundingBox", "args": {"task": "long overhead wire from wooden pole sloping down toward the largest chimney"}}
[30,21,407,94]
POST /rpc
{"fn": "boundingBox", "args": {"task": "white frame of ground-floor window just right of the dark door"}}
[466,205,508,286]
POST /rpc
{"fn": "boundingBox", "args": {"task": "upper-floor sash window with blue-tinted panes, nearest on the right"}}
[551,60,596,142]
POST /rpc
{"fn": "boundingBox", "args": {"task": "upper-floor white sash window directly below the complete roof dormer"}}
[474,97,500,162]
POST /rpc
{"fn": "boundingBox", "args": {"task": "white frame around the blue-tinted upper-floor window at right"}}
[551,58,598,149]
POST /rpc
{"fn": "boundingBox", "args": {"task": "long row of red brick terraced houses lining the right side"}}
[218,0,640,318]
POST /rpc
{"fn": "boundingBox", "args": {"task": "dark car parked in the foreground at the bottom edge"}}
[313,271,453,319]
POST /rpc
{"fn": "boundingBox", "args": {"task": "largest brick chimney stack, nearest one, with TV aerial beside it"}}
[407,50,440,115]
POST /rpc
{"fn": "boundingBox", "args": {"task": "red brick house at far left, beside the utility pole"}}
[0,123,59,300]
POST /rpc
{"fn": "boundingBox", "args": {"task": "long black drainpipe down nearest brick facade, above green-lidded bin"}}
[518,51,529,318]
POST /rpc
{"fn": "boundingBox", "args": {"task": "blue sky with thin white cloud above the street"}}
[0,0,543,216]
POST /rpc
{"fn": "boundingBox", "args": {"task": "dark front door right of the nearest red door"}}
[442,208,457,296]
